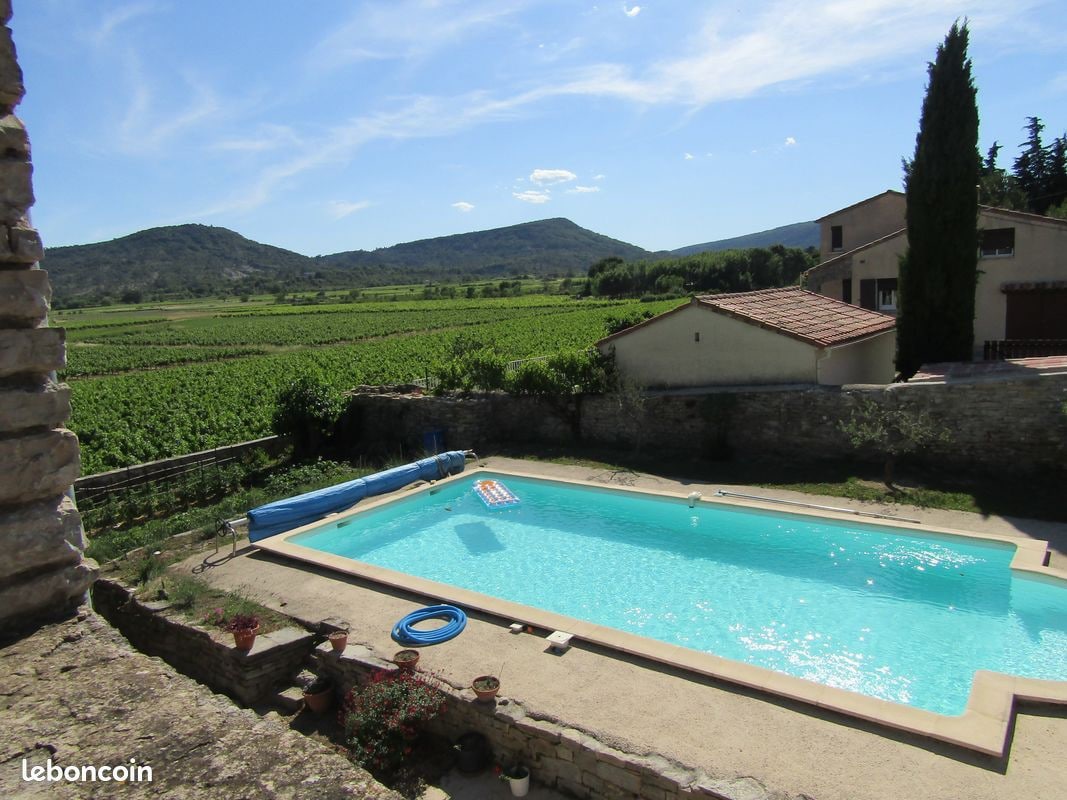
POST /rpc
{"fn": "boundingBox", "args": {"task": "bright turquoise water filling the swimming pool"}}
[291,473,1067,715]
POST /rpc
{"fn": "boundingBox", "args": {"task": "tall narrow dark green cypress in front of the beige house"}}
[896,22,982,379]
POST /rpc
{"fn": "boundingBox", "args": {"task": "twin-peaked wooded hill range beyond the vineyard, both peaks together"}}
[42,219,653,307]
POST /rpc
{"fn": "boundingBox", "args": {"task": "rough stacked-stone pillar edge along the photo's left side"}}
[0,0,96,631]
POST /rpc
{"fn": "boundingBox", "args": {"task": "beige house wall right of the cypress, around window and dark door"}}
[974,210,1067,345]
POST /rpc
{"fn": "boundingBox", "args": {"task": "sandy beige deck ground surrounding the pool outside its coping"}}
[172,458,1067,800]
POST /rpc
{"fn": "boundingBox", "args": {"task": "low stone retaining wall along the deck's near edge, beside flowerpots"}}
[93,578,793,800]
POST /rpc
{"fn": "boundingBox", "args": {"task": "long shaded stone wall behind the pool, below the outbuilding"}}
[350,374,1067,473]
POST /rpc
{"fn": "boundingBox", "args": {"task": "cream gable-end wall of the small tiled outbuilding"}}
[601,303,817,388]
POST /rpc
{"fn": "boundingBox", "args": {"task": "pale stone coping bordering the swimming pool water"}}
[254,467,1067,757]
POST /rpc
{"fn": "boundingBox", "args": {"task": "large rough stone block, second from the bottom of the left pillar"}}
[0,495,85,583]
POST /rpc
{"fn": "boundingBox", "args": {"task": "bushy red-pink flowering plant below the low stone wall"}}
[339,670,445,773]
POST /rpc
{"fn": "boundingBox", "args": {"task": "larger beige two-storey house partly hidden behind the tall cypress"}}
[803,191,1067,358]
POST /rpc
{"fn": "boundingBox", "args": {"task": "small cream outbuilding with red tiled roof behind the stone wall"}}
[596,287,896,388]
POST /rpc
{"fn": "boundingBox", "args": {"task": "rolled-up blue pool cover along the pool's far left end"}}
[248,450,465,542]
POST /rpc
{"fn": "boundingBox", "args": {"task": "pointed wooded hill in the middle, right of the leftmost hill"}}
[319,218,652,277]
